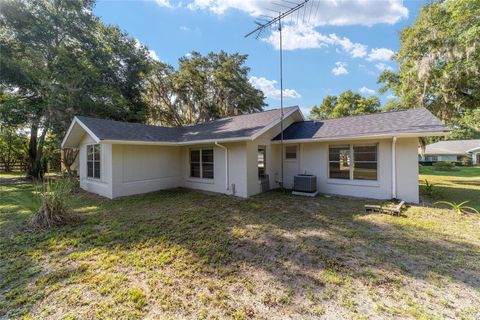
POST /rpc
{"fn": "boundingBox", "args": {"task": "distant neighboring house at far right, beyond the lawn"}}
[419,139,480,164]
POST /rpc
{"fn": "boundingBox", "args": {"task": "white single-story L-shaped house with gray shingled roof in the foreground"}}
[62,107,448,202]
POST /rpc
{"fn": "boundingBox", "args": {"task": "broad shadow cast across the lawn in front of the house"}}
[0,182,480,316]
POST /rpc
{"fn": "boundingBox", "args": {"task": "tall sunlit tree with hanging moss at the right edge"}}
[379,0,480,139]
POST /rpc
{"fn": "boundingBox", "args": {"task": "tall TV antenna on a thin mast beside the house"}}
[245,0,312,188]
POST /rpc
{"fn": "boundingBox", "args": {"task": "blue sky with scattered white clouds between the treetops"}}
[94,0,425,113]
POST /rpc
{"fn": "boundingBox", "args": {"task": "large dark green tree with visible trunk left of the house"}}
[0,0,151,176]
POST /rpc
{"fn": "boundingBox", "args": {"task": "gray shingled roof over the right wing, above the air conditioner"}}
[274,108,449,140]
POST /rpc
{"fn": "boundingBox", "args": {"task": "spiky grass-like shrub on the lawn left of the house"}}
[30,179,75,229]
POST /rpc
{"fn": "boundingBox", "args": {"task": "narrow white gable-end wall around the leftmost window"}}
[79,134,113,198]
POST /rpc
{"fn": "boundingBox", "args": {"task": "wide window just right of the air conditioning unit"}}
[328,144,378,180]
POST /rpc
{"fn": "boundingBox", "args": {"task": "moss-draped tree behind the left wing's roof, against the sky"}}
[146,51,265,126]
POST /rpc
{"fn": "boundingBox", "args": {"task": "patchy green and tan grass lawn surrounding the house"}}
[0,169,480,319]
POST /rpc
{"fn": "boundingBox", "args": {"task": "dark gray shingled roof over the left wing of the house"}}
[77,107,298,142]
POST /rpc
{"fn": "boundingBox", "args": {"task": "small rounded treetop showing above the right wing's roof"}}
[310,90,380,120]
